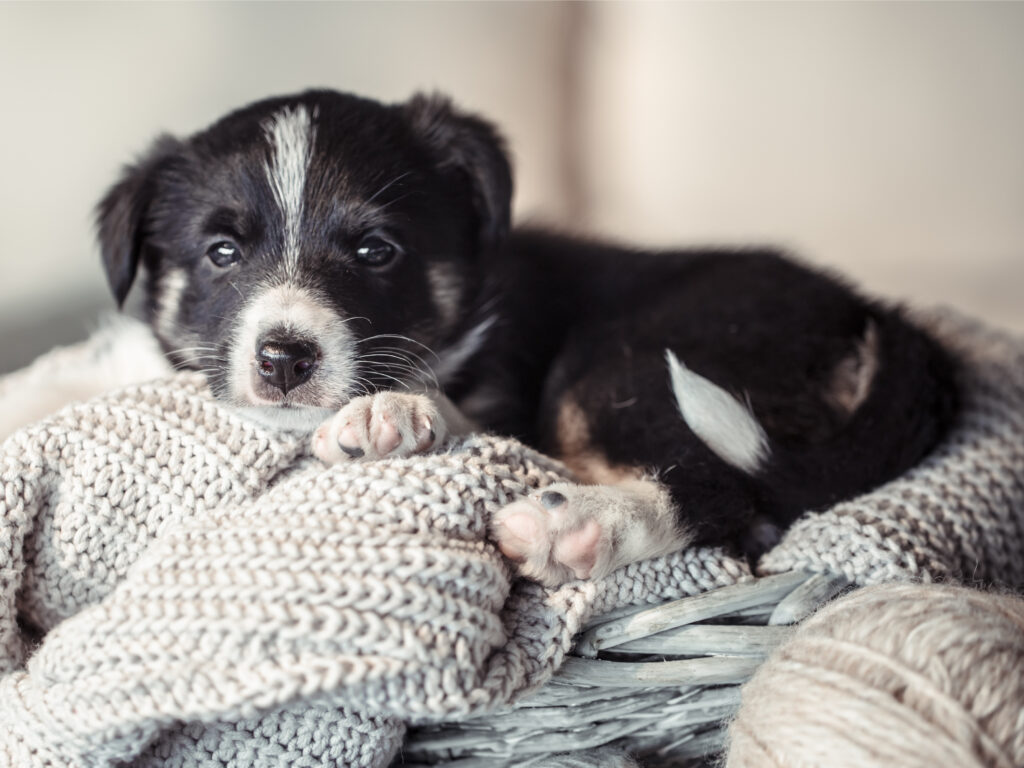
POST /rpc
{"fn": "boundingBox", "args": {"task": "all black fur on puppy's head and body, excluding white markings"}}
[99,91,955,552]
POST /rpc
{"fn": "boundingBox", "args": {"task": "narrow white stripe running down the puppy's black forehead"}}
[263,106,313,276]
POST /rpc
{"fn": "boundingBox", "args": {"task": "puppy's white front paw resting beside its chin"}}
[312,392,446,464]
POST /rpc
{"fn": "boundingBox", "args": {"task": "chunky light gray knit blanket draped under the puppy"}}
[0,312,1024,768]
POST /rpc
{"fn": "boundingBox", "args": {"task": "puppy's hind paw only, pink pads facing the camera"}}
[490,482,612,587]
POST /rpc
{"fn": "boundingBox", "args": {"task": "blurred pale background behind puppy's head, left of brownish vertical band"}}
[0,2,571,323]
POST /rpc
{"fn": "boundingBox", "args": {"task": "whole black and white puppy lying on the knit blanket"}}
[92,91,954,585]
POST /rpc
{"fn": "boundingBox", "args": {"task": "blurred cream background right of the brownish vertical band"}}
[579,2,1024,330]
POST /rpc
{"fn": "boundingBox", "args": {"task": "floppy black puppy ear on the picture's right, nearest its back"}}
[404,93,512,248]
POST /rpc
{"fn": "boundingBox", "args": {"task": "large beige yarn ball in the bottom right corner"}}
[726,584,1024,768]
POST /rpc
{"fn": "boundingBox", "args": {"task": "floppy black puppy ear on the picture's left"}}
[96,135,181,306]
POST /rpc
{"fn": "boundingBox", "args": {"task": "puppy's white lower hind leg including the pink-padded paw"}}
[492,479,693,587]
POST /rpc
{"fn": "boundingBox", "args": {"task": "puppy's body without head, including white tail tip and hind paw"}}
[450,232,953,581]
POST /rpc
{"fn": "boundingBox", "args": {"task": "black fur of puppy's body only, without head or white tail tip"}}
[471,232,955,541]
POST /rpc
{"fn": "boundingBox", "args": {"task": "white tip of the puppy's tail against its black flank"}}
[665,349,769,474]
